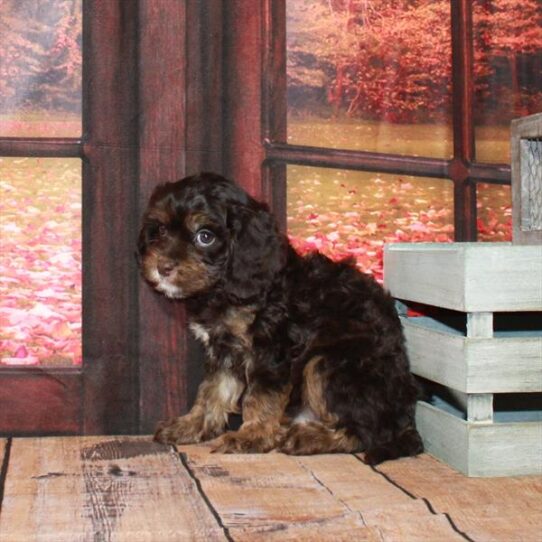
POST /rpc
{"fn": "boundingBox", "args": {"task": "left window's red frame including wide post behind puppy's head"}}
[0,0,222,435]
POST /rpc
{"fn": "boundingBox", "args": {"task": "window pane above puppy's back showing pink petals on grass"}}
[287,166,454,280]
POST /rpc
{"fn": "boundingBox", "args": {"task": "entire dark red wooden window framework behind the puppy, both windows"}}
[0,0,510,435]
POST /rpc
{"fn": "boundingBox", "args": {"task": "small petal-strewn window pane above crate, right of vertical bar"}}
[476,183,512,241]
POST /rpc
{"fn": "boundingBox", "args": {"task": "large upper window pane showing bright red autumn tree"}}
[286,0,453,158]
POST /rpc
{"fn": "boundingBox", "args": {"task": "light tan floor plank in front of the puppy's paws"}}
[182,446,466,541]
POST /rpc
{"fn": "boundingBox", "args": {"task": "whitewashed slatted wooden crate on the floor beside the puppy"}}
[384,243,542,476]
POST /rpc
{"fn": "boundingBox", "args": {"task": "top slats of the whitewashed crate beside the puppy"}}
[384,243,542,312]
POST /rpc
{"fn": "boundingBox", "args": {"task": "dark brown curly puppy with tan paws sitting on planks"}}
[138,173,423,464]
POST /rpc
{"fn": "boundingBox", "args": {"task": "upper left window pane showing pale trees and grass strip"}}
[0,0,82,137]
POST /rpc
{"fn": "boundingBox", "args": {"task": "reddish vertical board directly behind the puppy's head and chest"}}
[139,0,223,432]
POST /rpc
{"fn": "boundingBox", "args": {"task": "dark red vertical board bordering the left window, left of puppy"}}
[83,0,139,434]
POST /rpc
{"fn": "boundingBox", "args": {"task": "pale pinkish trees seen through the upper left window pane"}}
[0,0,82,113]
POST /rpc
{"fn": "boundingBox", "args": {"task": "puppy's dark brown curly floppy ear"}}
[224,205,287,301]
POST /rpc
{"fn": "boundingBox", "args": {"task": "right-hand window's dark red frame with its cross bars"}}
[249,0,511,242]
